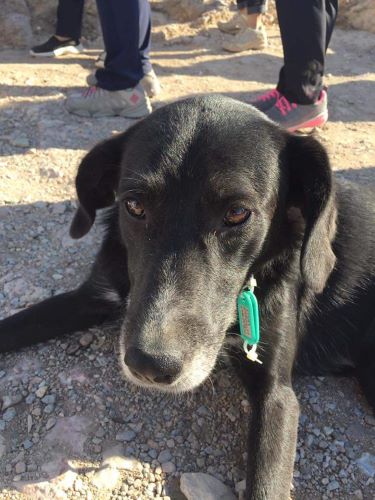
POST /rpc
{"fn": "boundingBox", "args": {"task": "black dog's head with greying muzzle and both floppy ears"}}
[71,97,335,392]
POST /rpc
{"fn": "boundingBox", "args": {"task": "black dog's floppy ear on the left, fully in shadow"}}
[70,134,125,239]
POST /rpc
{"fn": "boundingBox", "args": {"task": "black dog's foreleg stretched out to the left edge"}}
[0,282,116,352]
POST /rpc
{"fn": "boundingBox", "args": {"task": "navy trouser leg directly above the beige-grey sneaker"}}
[96,0,147,90]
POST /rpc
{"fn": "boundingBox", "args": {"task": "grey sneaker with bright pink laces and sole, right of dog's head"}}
[265,90,328,132]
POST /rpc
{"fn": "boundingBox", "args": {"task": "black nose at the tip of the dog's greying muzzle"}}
[125,347,182,384]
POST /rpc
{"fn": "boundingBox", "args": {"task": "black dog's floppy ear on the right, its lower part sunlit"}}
[287,136,336,293]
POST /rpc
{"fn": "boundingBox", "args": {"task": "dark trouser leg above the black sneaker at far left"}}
[55,0,84,41]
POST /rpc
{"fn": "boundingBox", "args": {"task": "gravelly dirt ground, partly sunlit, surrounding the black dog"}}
[0,4,375,500]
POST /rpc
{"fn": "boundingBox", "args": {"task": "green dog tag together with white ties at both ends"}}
[237,276,262,364]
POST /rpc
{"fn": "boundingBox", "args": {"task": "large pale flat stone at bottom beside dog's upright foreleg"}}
[180,472,236,500]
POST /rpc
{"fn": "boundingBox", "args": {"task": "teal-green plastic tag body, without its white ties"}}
[237,288,259,345]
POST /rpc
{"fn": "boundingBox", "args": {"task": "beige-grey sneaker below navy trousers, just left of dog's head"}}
[65,85,152,118]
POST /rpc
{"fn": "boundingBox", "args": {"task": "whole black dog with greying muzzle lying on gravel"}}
[0,97,375,500]
